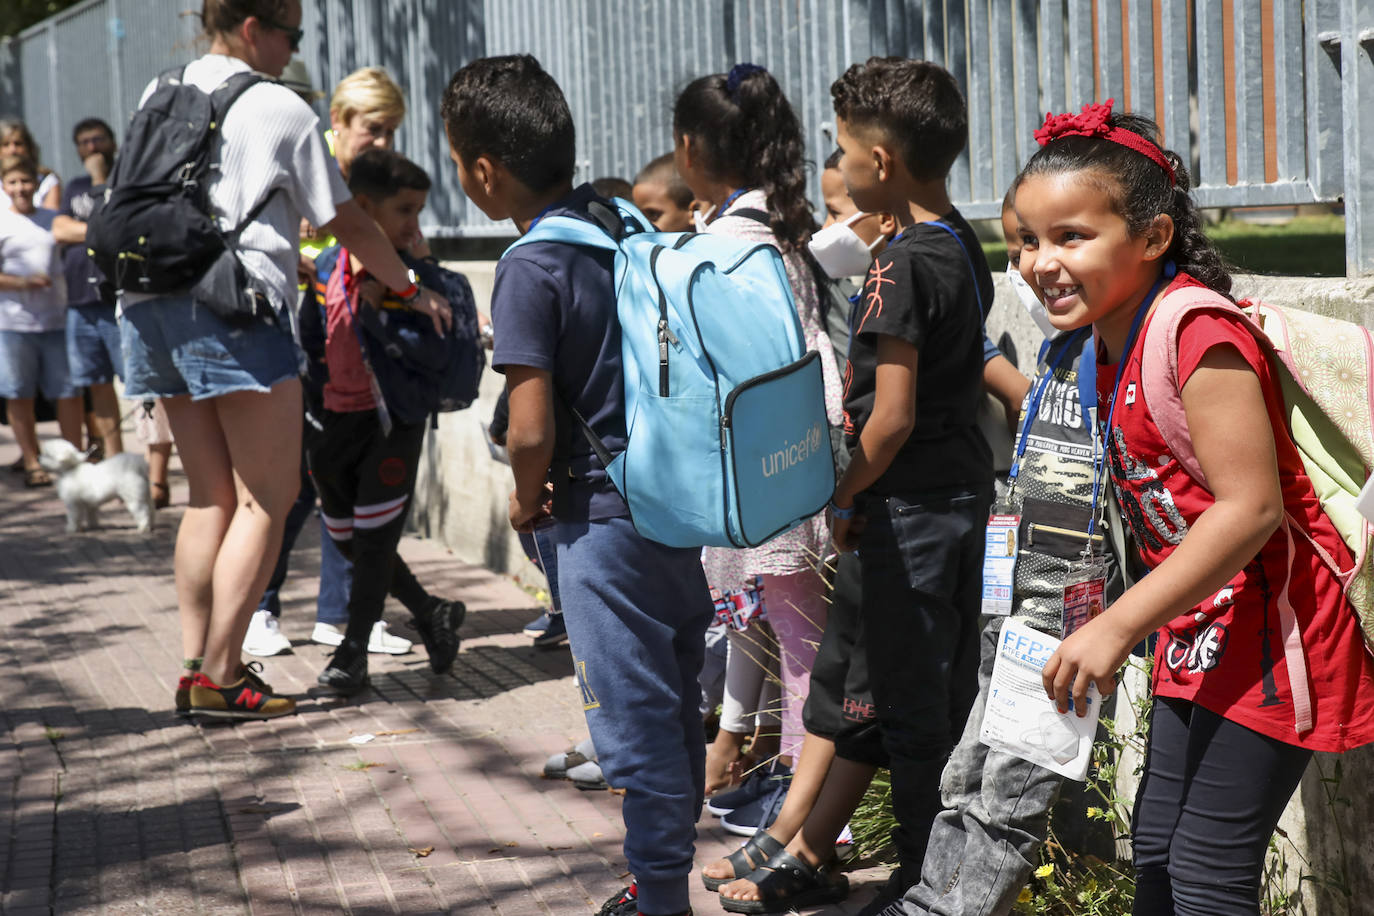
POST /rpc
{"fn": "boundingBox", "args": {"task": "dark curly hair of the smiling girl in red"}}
[1013,113,1231,297]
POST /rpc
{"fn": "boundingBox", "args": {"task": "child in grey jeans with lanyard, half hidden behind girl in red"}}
[901,192,1121,916]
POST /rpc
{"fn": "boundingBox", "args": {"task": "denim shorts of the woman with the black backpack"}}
[120,294,297,401]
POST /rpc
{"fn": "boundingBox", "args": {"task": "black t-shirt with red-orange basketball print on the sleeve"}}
[845,210,992,496]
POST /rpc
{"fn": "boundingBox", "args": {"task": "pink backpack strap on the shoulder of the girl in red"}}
[1140,286,1274,486]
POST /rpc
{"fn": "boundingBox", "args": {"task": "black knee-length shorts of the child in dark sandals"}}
[801,553,888,766]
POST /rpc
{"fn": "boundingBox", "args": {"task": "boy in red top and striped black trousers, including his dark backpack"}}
[305,150,484,695]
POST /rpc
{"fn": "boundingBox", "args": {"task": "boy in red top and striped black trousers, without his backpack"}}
[305,150,467,695]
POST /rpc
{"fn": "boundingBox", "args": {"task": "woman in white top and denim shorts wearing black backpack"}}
[111,0,451,718]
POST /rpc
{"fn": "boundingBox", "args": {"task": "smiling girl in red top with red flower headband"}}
[1015,102,1374,916]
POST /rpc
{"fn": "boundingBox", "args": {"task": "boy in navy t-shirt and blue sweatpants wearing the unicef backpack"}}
[442,55,713,916]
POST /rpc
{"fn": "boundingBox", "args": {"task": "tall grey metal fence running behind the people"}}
[0,0,1374,275]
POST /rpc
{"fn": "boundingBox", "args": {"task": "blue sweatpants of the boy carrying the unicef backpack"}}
[554,518,714,915]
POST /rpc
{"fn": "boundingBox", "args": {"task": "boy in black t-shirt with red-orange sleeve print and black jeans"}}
[830,58,992,911]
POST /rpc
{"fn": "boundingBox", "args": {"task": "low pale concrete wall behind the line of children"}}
[411,261,1374,916]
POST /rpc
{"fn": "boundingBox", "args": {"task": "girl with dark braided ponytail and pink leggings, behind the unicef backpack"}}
[673,63,841,807]
